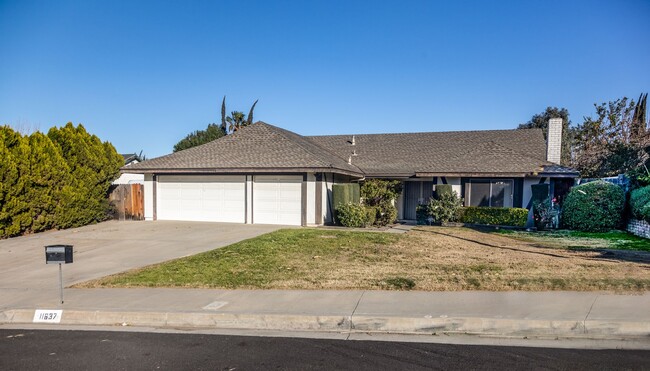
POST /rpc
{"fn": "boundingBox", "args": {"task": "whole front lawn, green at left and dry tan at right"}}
[80,227,650,291]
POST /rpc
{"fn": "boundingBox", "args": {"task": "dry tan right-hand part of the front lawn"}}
[390,227,650,291]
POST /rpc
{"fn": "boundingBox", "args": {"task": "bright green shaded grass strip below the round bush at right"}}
[496,230,650,251]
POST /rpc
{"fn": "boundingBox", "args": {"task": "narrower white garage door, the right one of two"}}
[253,175,302,225]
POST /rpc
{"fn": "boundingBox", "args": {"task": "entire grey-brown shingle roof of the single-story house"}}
[123,122,578,177]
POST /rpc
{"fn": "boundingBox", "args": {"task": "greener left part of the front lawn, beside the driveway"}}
[81,229,400,288]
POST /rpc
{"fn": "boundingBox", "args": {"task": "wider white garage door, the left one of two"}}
[156,175,246,223]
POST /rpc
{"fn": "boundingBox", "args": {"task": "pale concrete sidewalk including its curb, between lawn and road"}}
[0,289,650,342]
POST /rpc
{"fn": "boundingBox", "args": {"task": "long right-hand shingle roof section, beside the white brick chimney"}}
[309,129,577,176]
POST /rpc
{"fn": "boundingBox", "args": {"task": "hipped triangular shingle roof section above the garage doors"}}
[123,122,363,176]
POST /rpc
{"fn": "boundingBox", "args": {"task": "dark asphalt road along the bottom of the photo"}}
[0,329,650,370]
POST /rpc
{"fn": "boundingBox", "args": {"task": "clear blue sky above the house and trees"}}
[0,0,650,158]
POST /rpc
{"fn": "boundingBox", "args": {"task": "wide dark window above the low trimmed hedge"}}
[465,179,514,207]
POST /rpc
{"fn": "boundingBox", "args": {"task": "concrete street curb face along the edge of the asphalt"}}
[0,309,650,341]
